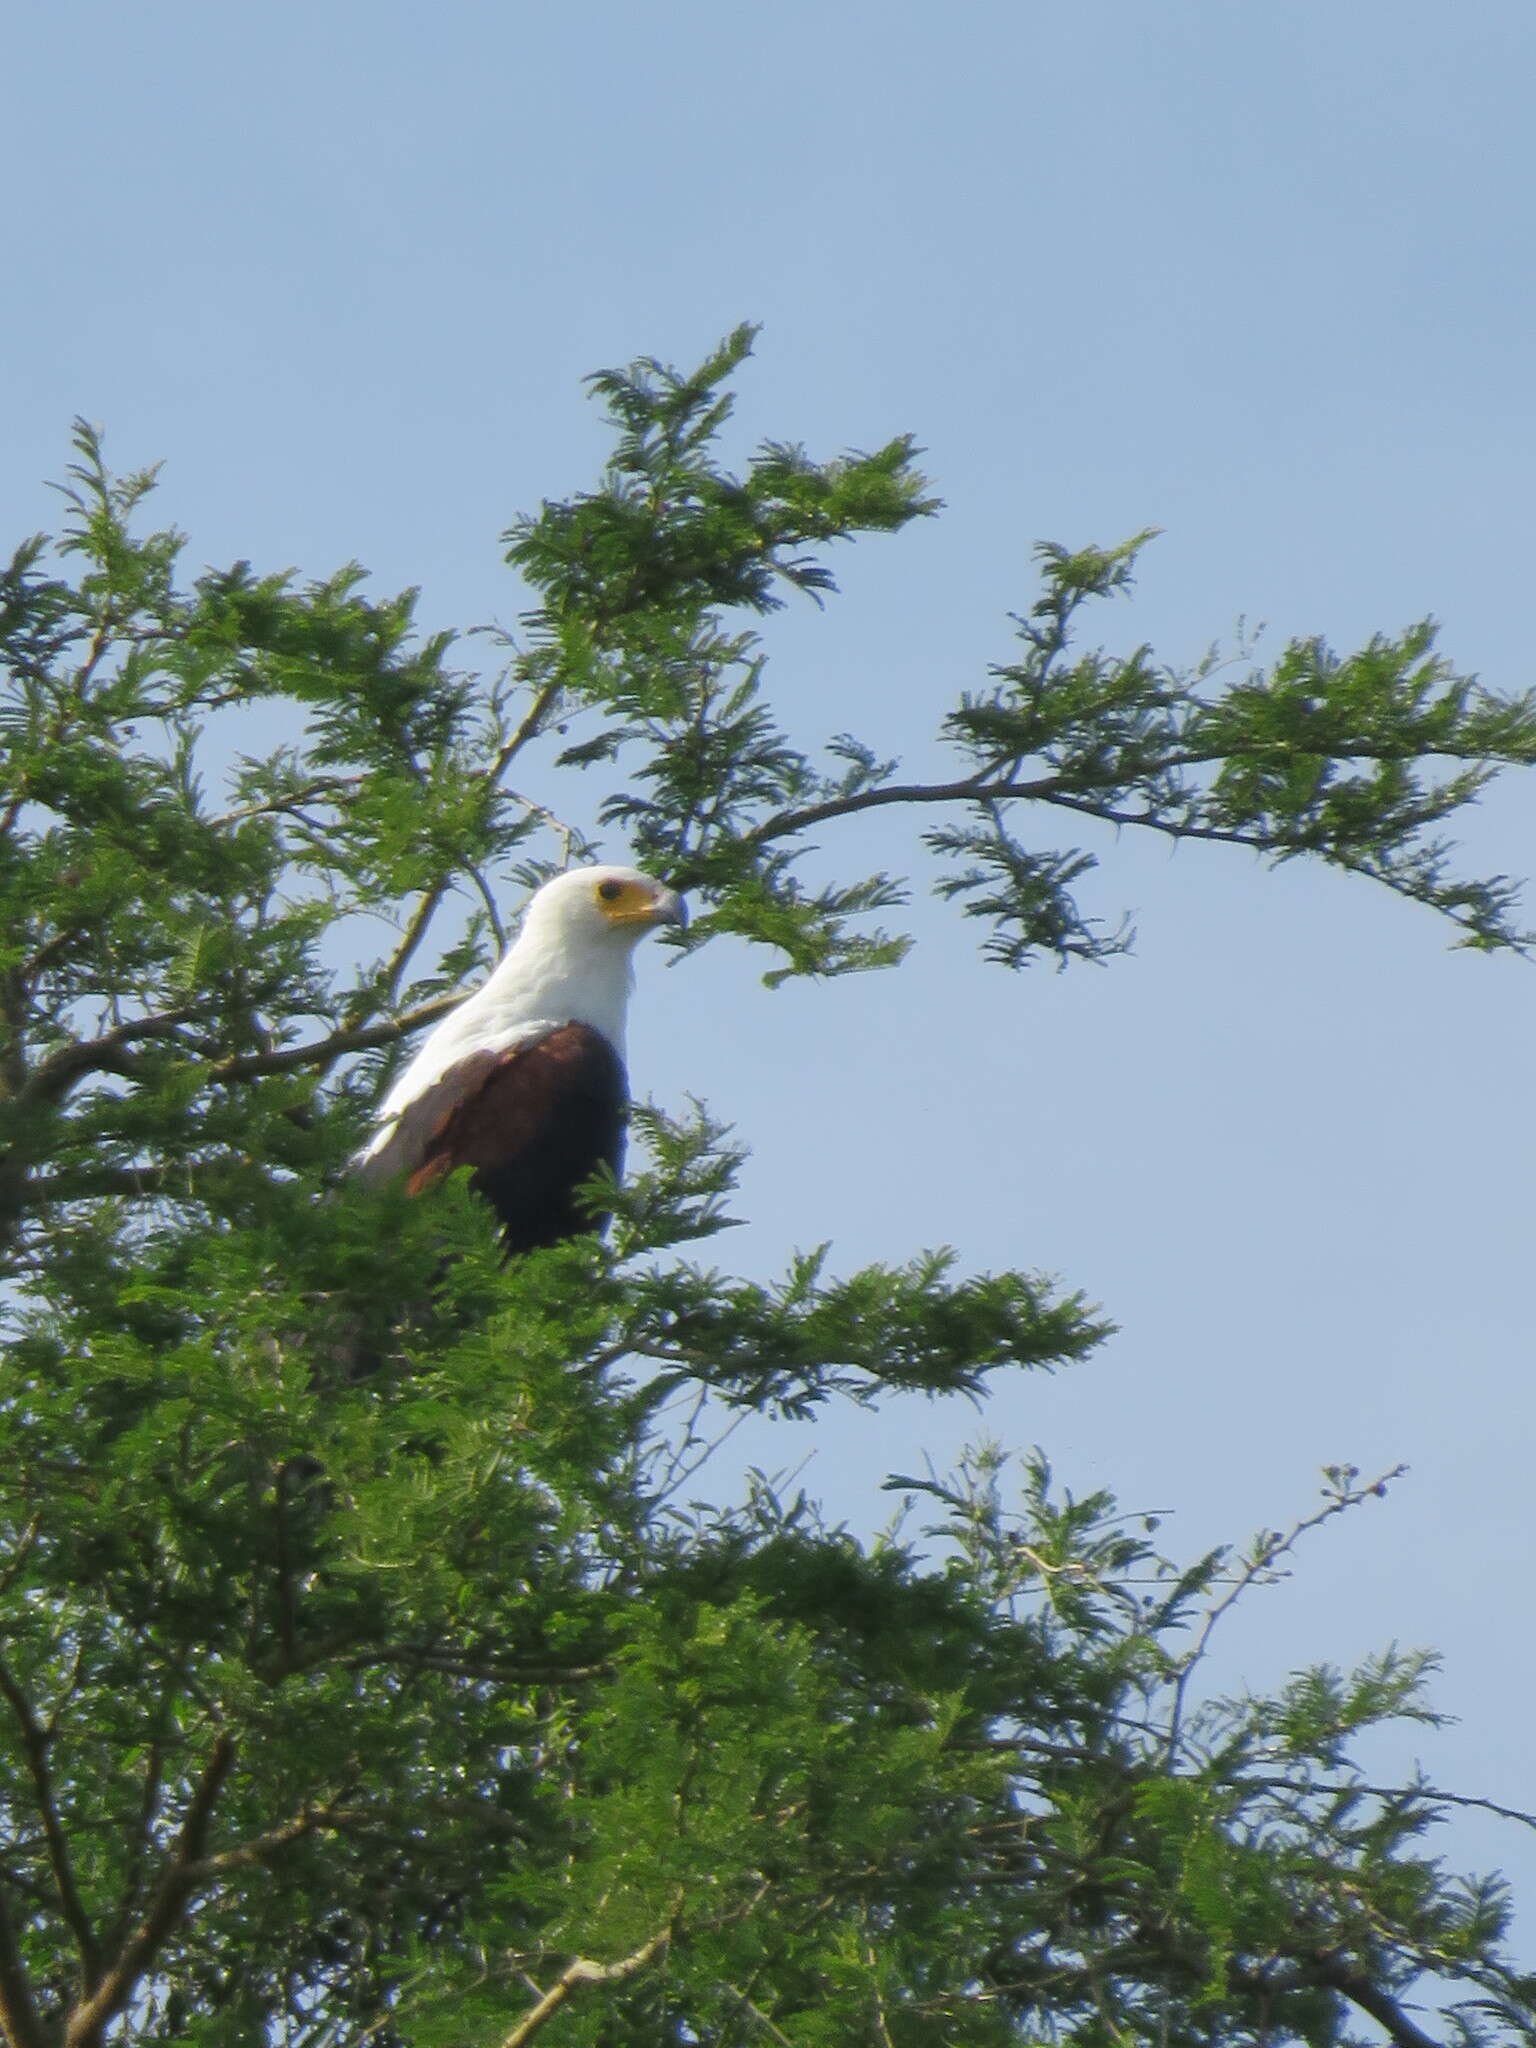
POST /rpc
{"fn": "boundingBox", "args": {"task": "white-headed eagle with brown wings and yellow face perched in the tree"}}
[356,868,686,1255]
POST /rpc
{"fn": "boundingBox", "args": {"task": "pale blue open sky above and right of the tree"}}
[12,0,1536,1941]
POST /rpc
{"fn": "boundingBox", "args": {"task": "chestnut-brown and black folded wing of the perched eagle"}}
[401,1024,629,1251]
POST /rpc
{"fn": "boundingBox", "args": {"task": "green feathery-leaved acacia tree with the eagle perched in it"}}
[0,330,1536,2048]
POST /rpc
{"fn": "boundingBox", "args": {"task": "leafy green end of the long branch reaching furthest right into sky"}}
[928,535,1536,967]
